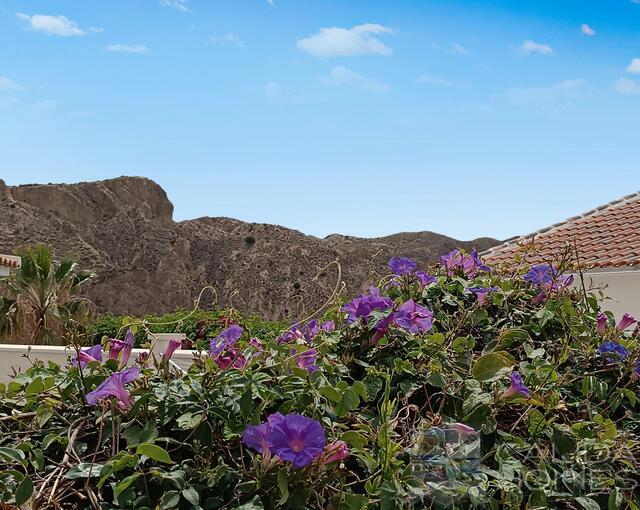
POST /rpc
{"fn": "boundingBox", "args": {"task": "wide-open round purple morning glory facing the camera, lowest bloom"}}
[268,414,327,468]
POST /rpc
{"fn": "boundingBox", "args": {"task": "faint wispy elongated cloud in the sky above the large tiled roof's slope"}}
[504,79,587,107]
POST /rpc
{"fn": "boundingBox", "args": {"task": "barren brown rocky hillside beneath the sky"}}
[0,177,497,319]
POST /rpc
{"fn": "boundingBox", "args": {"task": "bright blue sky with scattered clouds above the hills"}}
[0,0,640,239]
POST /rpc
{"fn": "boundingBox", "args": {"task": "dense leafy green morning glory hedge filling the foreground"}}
[0,253,640,510]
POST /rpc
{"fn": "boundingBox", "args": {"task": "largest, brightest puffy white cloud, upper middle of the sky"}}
[298,23,393,58]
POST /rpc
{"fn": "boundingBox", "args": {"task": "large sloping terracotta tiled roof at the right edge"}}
[481,192,640,267]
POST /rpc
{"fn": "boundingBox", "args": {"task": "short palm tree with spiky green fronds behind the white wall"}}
[0,245,92,344]
